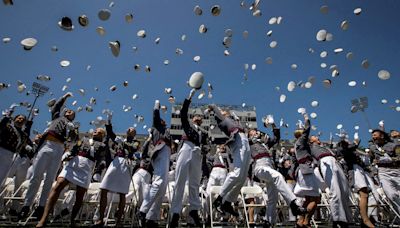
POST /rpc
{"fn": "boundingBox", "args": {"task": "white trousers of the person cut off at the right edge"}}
[378,167,400,213]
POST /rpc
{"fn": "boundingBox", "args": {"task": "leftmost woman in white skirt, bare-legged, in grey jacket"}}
[36,128,106,227]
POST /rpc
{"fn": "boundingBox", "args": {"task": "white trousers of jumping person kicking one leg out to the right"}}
[254,157,296,224]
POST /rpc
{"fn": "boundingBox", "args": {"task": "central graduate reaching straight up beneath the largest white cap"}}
[169,89,208,228]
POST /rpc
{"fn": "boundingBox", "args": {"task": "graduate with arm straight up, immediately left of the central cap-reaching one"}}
[139,100,172,227]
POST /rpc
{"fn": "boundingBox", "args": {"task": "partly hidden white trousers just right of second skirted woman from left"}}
[126,168,151,208]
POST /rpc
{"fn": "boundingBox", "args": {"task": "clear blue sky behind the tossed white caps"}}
[0,0,400,143]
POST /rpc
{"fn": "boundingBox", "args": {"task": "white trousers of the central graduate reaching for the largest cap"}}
[171,141,203,214]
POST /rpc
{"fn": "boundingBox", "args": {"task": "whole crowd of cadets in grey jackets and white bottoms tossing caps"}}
[0,89,400,228]
